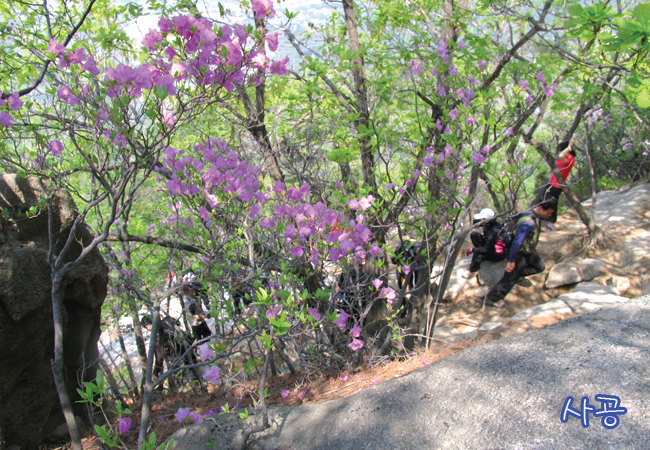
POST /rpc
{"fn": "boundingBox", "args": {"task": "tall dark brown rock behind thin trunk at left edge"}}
[0,175,108,450]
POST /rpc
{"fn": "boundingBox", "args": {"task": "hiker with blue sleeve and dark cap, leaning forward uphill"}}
[485,197,557,308]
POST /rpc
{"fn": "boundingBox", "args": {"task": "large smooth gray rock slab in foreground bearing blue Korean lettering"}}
[166,297,650,450]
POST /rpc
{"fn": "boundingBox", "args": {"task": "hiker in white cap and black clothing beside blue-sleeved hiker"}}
[463,208,507,278]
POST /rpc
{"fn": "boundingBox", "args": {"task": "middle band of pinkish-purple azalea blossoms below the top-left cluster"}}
[158,139,384,266]
